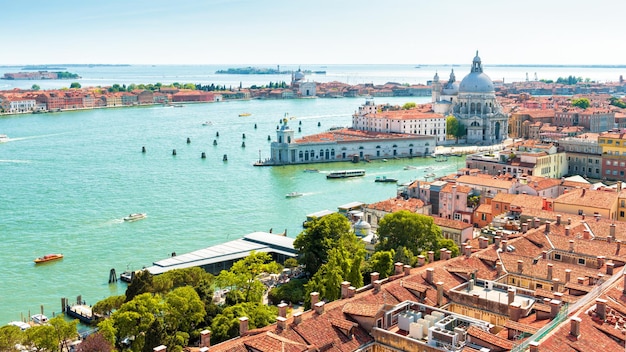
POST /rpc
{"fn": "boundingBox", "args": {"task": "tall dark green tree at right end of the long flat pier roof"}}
[293,213,350,276]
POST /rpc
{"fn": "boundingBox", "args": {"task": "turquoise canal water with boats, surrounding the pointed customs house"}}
[0,98,468,324]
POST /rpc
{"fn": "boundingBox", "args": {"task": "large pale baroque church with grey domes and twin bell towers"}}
[432,51,509,145]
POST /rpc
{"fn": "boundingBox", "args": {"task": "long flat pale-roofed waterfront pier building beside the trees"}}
[146,232,297,275]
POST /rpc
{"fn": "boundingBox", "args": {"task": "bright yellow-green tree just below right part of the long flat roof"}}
[217,251,281,302]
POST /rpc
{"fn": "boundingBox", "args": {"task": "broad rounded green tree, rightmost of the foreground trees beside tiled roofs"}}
[376,210,441,255]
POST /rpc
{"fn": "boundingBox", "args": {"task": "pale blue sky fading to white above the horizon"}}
[0,0,626,65]
